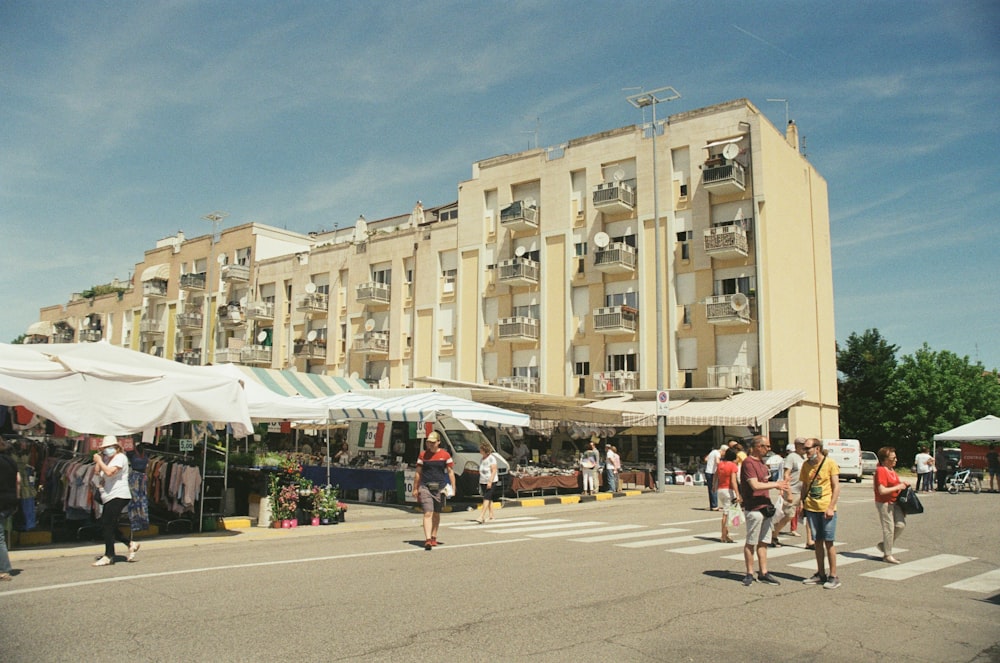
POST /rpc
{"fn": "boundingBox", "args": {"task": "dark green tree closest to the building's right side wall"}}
[837,329,899,450]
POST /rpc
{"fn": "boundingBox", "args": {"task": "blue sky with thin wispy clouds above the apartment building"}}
[0,0,1000,368]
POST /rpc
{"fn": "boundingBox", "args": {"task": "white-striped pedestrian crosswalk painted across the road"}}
[442,516,1000,594]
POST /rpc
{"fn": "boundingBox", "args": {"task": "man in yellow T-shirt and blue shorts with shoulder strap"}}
[799,437,840,589]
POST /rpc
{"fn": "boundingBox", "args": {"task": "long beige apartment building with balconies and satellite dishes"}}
[25,99,838,437]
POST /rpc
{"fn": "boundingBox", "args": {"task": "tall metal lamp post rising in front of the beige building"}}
[625,86,681,493]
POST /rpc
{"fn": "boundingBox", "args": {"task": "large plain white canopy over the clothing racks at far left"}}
[0,342,253,437]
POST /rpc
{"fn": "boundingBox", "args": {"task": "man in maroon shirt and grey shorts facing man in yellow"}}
[740,435,788,587]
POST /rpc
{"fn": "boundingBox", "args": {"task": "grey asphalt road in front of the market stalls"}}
[0,479,1000,663]
